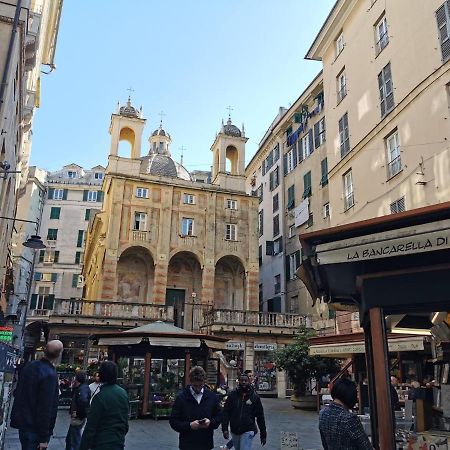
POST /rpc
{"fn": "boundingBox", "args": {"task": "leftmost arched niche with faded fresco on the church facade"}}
[117,246,155,303]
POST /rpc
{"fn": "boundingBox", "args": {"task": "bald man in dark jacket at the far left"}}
[11,340,63,450]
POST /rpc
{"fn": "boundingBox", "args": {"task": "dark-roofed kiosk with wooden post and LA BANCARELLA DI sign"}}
[298,203,450,450]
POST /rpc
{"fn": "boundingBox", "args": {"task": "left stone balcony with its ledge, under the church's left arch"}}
[28,298,173,327]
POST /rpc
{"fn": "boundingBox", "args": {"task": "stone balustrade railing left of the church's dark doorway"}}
[30,298,173,322]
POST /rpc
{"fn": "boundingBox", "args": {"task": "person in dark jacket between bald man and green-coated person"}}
[66,371,91,450]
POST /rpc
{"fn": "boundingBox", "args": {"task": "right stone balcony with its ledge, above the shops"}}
[202,309,311,333]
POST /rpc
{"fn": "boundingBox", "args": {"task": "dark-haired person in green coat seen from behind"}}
[80,361,129,450]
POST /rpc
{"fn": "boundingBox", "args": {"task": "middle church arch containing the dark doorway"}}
[166,252,202,330]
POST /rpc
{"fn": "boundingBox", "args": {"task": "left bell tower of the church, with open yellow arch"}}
[109,97,145,159]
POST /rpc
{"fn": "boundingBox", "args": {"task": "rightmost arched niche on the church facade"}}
[214,256,246,310]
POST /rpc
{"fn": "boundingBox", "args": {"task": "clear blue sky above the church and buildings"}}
[31,0,334,170]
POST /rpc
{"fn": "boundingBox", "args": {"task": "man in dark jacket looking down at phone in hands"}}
[169,366,222,450]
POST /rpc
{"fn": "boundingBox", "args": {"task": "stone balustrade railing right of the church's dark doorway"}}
[203,309,311,328]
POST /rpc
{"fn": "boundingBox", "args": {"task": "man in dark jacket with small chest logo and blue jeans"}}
[222,373,267,450]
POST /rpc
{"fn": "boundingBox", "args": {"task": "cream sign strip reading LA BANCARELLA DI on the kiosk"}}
[317,222,450,264]
